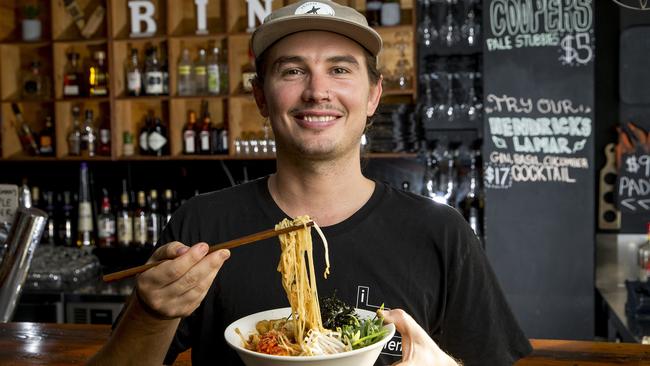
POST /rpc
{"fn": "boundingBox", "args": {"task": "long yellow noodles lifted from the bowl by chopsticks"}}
[275,215,329,353]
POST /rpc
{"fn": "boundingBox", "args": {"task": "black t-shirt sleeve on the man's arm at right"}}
[438,220,532,366]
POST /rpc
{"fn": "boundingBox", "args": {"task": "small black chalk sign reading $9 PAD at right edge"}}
[617,151,650,213]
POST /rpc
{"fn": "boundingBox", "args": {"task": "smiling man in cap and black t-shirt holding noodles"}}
[91,0,530,365]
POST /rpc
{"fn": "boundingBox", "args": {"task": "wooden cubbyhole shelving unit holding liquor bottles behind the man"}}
[0,0,417,161]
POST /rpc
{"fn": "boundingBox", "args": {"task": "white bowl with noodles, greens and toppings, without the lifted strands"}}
[224,307,395,366]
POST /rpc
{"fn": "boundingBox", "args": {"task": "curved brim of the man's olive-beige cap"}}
[252,15,382,57]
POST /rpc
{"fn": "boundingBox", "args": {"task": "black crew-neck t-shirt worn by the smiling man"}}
[160,178,531,366]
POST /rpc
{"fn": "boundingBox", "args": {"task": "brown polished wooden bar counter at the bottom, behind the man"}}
[0,323,650,366]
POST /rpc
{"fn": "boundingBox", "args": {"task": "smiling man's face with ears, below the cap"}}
[255,31,381,160]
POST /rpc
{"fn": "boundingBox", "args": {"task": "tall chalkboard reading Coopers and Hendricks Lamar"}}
[483,0,595,339]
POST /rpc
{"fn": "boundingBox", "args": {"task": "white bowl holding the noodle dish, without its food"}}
[224,308,395,366]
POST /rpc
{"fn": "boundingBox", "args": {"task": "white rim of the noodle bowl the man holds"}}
[223,307,395,362]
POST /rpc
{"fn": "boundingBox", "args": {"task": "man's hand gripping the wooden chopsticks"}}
[135,241,230,319]
